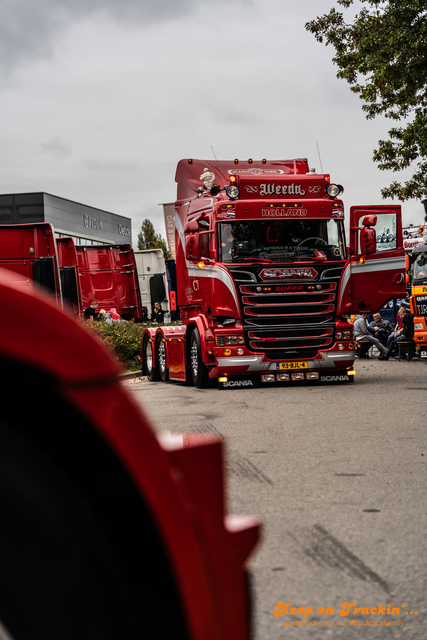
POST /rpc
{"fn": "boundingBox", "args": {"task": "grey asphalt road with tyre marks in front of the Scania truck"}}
[123,359,427,640]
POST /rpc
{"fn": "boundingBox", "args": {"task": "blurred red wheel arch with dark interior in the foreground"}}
[0,270,259,640]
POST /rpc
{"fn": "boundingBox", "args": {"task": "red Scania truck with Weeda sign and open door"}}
[142,158,405,388]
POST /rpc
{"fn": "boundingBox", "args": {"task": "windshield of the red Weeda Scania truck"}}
[218,220,345,262]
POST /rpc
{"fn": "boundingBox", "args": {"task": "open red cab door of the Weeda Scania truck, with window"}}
[350,205,406,313]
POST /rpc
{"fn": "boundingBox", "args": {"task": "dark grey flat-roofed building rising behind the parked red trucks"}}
[0,193,132,245]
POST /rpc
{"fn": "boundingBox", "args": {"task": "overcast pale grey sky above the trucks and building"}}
[0,0,423,244]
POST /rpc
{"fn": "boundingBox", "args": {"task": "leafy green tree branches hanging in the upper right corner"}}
[305,0,427,201]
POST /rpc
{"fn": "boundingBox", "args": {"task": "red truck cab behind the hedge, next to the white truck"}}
[76,244,141,320]
